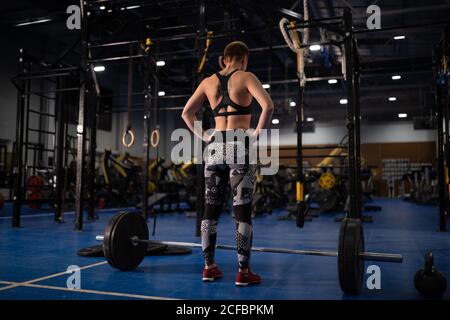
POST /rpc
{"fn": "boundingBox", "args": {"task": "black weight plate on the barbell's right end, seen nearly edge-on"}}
[338,218,364,294]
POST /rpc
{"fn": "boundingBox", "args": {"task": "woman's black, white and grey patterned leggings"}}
[201,143,256,268]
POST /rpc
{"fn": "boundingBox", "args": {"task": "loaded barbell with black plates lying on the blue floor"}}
[96,211,403,294]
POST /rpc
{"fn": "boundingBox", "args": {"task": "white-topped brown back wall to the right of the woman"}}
[280,121,436,196]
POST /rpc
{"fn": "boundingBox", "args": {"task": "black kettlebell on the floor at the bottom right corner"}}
[414,252,447,298]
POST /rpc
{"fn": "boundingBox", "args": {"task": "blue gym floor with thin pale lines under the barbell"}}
[0,200,450,300]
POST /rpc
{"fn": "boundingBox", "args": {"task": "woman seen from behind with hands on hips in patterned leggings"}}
[182,41,274,286]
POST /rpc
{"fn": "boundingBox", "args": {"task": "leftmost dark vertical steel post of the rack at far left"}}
[12,49,26,228]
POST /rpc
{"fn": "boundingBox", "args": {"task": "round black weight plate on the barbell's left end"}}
[104,213,148,271]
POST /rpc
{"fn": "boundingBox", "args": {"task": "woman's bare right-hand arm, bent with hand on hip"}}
[246,72,274,135]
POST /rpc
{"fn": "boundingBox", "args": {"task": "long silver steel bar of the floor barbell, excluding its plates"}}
[95,235,403,263]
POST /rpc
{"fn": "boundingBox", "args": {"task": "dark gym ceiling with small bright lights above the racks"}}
[0,0,450,125]
